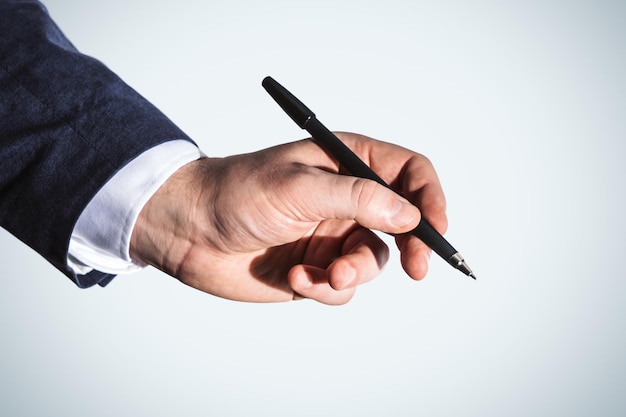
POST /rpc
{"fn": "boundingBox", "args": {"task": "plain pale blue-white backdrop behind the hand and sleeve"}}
[0,0,626,417]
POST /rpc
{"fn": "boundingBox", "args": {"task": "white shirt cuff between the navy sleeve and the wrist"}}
[67,140,204,275]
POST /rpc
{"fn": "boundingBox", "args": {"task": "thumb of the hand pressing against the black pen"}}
[304,171,421,234]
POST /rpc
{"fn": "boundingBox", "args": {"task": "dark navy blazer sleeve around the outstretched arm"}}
[0,0,194,288]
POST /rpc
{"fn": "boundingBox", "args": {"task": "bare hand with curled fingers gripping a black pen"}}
[130,133,447,304]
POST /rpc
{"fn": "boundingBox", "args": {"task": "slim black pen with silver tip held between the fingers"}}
[262,77,476,279]
